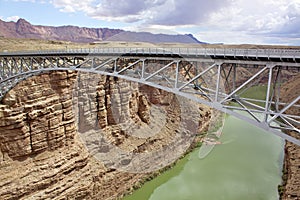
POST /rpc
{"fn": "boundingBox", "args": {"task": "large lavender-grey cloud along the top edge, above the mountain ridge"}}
[51,0,231,26]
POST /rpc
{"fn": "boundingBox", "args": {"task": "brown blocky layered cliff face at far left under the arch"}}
[0,72,76,160]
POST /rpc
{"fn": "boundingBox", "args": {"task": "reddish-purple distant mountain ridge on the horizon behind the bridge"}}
[0,19,202,43]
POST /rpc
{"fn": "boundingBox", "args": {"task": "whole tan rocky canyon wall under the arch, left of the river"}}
[0,71,210,199]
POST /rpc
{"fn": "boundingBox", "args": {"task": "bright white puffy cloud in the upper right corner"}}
[208,0,300,34]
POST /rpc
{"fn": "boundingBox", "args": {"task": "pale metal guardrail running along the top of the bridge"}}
[0,47,300,60]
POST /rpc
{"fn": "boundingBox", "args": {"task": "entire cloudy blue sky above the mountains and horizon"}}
[0,0,300,45]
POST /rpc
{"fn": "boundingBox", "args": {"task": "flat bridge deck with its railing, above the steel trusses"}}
[0,47,300,62]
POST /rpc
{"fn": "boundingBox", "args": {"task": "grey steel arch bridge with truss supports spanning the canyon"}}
[0,48,300,145]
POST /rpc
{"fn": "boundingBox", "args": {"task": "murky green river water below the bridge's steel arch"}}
[124,112,284,200]
